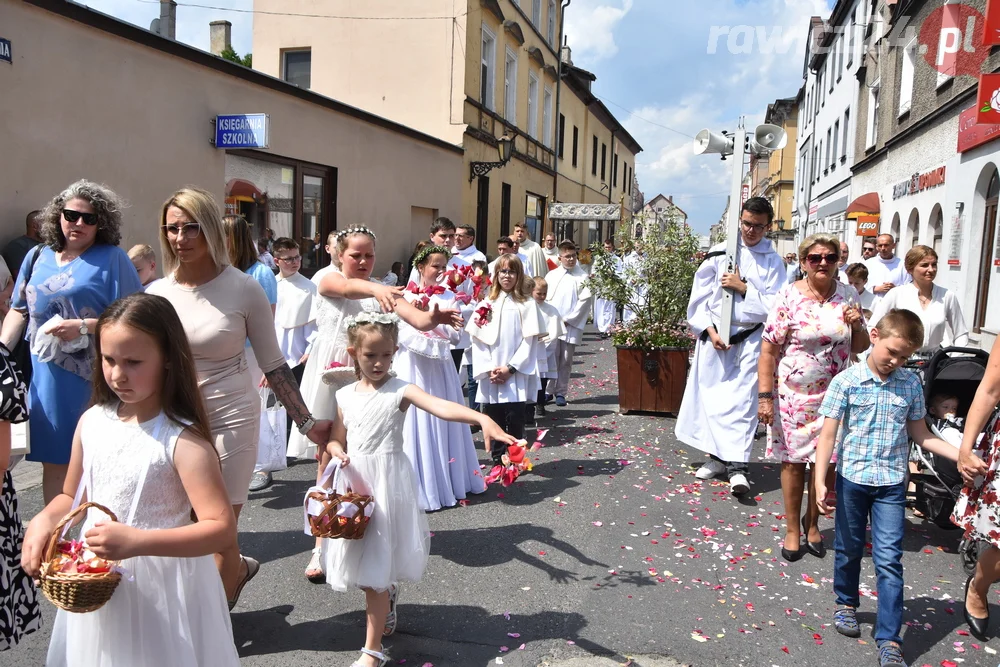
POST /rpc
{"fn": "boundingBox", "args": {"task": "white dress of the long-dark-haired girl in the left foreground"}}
[46,406,240,667]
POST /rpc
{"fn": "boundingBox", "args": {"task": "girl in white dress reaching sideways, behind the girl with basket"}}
[287,226,462,583]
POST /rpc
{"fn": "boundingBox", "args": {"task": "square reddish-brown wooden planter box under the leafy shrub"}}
[617,347,690,415]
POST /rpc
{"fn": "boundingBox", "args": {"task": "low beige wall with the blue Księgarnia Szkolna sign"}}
[0,1,467,272]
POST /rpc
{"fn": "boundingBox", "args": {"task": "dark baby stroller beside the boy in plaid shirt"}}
[910,347,989,573]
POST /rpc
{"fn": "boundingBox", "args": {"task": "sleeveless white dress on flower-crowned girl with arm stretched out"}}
[322,378,428,591]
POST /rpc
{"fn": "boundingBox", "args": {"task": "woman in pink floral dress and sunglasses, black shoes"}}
[757,234,871,562]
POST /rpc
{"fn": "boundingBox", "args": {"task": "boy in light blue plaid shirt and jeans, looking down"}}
[813,309,958,667]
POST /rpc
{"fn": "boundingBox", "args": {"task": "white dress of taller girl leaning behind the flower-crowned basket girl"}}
[287,269,381,458]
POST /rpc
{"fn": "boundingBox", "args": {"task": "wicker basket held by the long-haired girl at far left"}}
[38,503,122,613]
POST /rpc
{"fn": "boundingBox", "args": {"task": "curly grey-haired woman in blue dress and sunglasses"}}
[0,181,142,503]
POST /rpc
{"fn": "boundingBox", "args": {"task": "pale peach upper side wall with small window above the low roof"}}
[253,0,466,144]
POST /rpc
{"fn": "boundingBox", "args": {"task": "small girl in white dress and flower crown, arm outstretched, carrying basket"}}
[323,313,515,667]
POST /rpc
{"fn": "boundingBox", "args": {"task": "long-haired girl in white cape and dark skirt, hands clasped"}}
[466,255,546,465]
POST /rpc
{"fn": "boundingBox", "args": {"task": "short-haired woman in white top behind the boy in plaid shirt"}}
[871,245,969,357]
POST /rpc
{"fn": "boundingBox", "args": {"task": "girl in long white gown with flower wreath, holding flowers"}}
[393,245,486,511]
